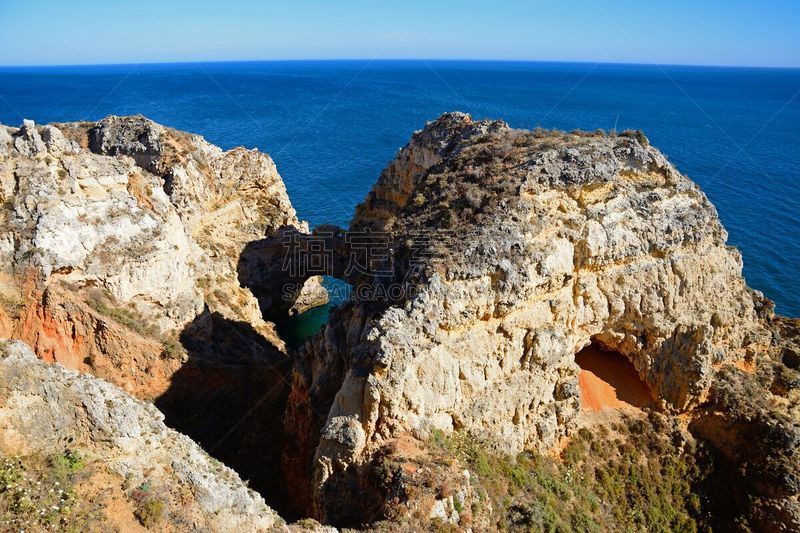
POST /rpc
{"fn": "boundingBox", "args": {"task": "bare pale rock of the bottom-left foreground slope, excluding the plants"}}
[0,341,285,531]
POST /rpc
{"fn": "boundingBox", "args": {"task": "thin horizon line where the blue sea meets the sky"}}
[0,57,800,70]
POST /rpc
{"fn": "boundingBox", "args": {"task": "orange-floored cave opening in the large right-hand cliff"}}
[575,341,654,411]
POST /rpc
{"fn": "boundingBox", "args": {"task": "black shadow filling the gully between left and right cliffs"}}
[156,310,293,519]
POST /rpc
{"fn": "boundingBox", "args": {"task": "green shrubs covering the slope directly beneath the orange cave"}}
[428,417,708,532]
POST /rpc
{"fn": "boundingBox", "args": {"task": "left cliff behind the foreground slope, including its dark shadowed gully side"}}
[0,116,327,516]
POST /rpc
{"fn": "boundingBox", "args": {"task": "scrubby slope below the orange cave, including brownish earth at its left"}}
[375,413,712,532]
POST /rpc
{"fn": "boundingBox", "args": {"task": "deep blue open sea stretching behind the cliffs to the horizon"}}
[0,61,800,316]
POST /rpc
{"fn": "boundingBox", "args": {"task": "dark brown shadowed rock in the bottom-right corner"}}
[688,363,800,531]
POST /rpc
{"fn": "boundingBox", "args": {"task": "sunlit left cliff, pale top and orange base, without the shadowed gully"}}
[0,116,325,395]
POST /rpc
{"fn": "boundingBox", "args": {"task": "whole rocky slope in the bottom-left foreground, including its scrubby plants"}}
[0,341,285,531]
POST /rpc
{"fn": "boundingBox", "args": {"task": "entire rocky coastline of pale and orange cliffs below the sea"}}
[0,113,800,531]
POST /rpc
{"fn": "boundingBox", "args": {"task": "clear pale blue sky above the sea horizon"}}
[0,0,800,67]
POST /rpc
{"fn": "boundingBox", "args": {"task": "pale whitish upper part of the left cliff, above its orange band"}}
[0,116,319,345]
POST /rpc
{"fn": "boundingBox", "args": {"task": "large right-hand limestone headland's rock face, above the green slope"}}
[285,114,771,523]
